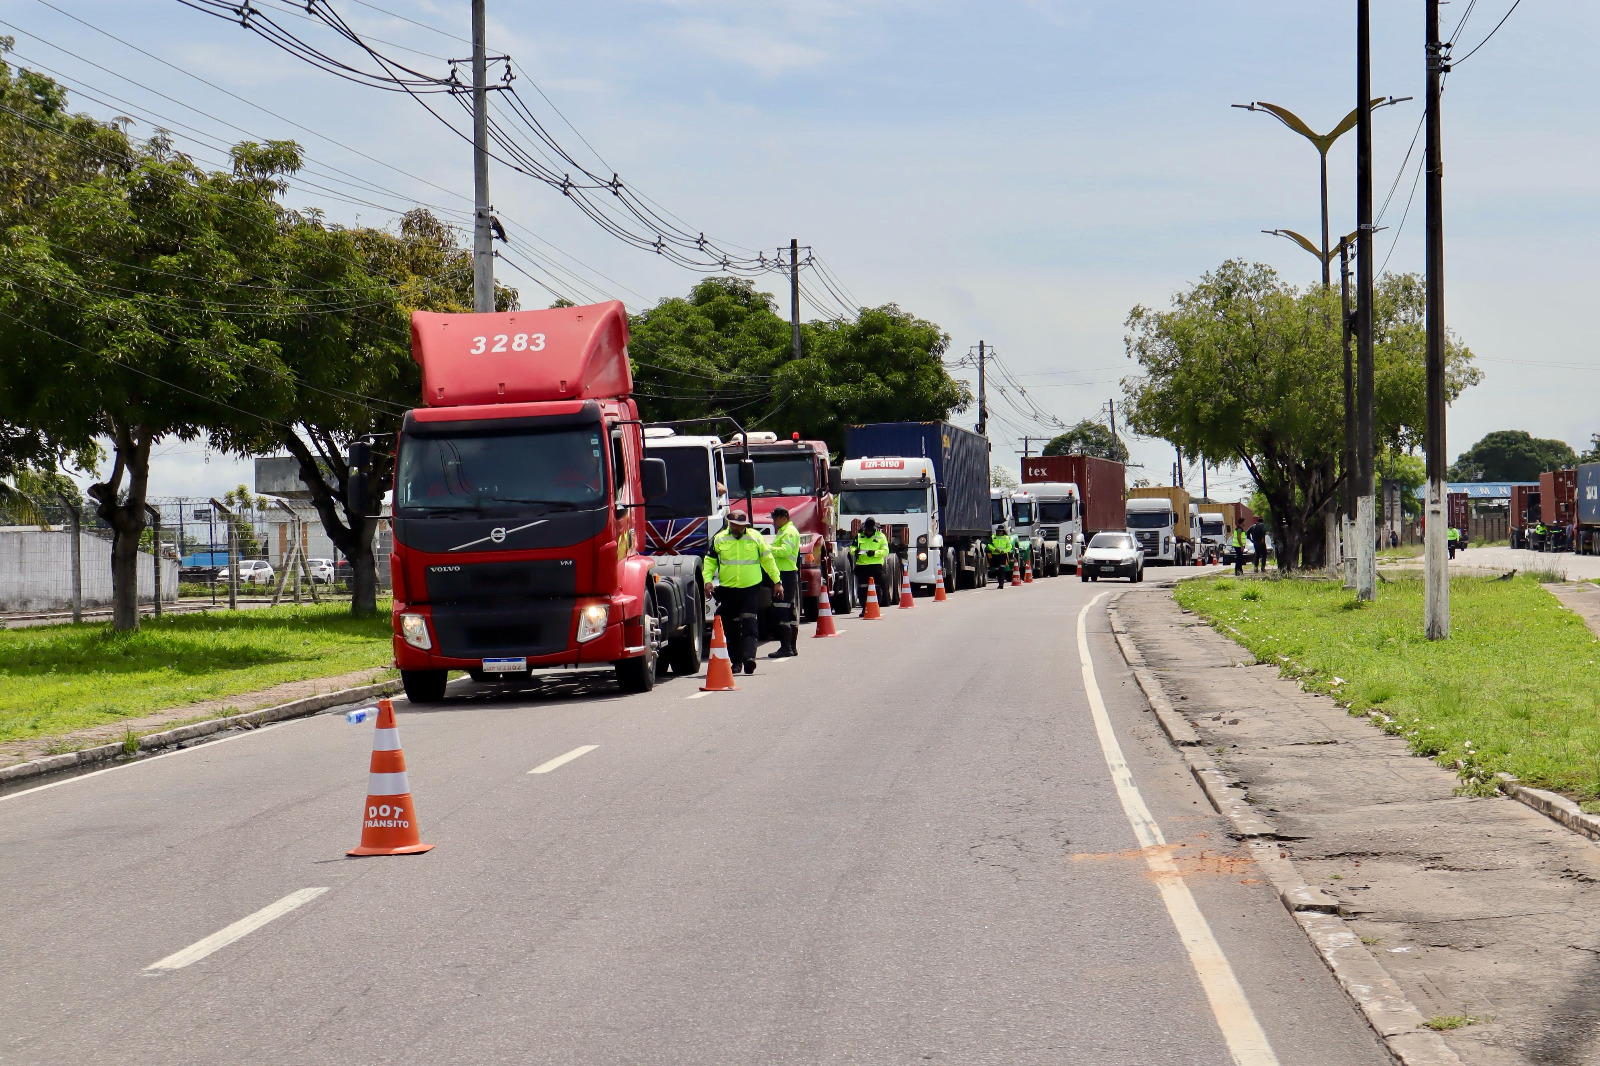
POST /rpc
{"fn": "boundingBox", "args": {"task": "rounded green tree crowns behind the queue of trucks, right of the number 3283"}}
[629,277,971,451]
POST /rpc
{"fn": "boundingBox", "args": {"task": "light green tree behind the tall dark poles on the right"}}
[1123,259,1480,570]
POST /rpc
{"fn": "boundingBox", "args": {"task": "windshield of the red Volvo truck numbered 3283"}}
[395,426,606,515]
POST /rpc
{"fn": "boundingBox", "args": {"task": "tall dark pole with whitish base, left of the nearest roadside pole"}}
[1355,0,1378,600]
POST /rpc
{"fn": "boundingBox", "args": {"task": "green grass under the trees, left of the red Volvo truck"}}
[0,603,392,741]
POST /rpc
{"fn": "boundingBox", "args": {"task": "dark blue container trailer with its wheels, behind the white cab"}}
[845,423,990,592]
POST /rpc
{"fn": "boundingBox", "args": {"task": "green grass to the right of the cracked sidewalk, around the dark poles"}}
[1178,575,1600,799]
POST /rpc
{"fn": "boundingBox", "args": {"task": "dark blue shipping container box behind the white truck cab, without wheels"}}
[845,423,989,538]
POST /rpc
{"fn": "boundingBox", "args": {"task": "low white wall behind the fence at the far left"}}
[0,527,178,611]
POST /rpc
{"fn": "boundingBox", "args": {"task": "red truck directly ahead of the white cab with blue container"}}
[722,432,853,621]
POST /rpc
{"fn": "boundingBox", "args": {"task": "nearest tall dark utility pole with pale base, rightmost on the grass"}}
[1422,0,1450,640]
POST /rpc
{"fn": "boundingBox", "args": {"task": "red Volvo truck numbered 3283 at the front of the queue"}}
[390,301,699,703]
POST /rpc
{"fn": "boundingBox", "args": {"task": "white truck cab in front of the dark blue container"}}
[838,456,944,592]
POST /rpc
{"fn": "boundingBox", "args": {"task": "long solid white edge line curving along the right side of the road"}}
[1078,592,1278,1066]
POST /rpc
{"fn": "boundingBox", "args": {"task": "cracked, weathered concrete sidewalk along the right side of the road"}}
[1117,585,1600,1066]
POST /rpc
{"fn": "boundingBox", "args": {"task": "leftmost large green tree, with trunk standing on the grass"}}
[0,60,298,631]
